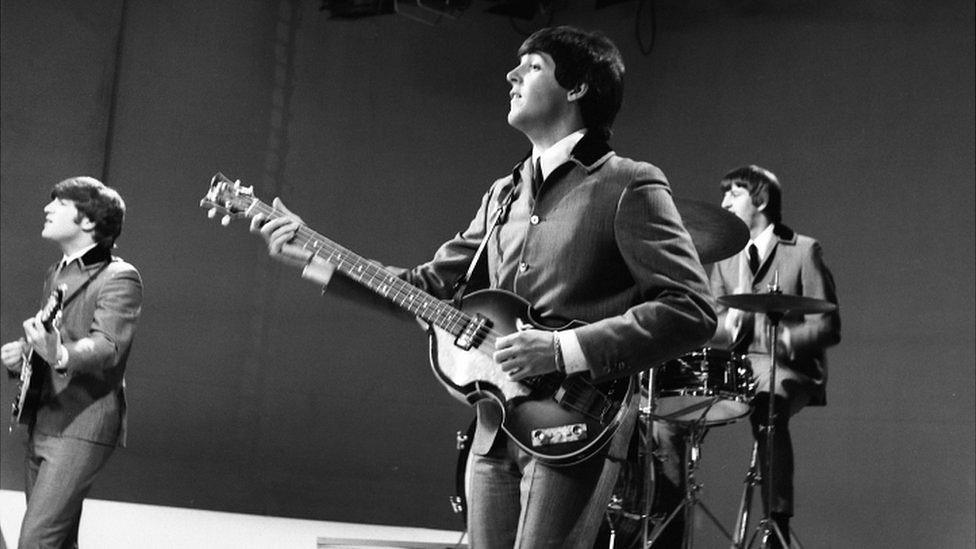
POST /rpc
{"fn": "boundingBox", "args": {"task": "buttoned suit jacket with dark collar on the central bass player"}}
[392,134,715,454]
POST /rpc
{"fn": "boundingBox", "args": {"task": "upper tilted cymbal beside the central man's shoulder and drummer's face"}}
[674,198,749,263]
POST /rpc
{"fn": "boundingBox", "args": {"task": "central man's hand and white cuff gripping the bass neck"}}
[251,198,336,287]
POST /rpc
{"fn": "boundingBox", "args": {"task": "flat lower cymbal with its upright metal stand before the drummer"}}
[718,278,837,548]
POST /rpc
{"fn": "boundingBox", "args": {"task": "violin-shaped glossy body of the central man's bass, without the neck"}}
[430,290,634,465]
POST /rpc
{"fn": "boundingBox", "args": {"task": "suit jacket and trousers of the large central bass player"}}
[390,134,715,547]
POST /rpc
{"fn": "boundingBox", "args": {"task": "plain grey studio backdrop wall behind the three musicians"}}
[0,0,976,547]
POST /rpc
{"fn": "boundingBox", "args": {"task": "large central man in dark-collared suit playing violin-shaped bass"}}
[251,27,715,548]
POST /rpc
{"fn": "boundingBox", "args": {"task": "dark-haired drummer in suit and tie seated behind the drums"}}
[658,165,840,547]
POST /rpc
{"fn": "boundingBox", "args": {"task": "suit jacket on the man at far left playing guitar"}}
[32,246,142,446]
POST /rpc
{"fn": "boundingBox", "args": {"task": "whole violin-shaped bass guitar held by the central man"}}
[200,173,635,465]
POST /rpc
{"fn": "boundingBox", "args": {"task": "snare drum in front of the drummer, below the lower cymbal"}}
[651,347,755,425]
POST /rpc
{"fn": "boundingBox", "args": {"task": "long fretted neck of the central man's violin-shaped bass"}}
[248,199,471,335]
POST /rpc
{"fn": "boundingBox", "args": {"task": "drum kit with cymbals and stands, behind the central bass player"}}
[606,199,836,549]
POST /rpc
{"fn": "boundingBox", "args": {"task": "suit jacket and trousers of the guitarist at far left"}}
[20,246,142,547]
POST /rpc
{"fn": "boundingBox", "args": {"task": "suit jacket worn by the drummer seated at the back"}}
[710,224,840,405]
